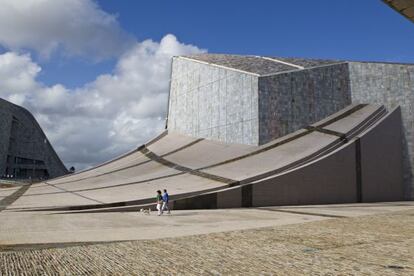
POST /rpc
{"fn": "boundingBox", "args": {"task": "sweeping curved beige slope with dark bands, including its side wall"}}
[3,104,402,212]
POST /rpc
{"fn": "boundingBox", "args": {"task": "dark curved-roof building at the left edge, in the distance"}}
[0,99,68,179]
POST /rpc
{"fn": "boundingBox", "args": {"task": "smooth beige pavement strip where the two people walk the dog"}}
[0,202,414,245]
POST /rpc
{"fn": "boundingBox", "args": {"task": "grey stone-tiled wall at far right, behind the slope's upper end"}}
[349,62,414,199]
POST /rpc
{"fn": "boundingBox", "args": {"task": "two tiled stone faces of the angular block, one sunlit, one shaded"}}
[168,58,351,145]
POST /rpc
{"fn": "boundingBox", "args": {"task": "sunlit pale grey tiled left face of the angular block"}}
[168,57,258,145]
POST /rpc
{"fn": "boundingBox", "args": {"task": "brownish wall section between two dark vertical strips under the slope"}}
[252,141,357,207]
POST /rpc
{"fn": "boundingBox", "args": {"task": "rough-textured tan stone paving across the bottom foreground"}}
[0,207,414,275]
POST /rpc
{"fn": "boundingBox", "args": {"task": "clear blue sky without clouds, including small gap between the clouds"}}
[40,0,414,87]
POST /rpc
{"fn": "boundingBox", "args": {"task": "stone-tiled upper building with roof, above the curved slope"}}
[168,54,414,199]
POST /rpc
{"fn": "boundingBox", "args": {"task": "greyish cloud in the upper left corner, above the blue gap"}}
[0,0,134,60]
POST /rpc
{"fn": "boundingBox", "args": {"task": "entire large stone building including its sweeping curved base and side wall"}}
[0,54,408,212]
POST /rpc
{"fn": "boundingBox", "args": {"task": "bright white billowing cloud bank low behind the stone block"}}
[0,34,203,169]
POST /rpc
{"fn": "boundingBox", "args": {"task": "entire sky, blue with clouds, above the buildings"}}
[0,0,414,169]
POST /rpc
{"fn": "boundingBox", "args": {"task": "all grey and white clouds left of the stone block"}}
[0,0,205,168]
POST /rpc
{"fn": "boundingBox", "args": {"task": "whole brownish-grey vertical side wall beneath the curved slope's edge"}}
[170,105,403,209]
